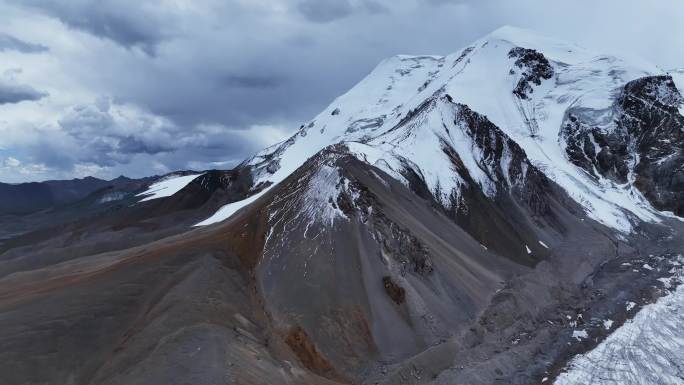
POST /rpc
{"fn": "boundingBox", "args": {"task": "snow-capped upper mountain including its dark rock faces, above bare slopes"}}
[202,27,684,232]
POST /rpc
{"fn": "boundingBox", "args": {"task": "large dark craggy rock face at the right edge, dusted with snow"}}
[561,76,684,216]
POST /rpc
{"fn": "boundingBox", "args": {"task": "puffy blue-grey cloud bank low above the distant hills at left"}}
[38,99,258,175]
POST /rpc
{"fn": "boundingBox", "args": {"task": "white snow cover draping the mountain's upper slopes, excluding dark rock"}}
[202,27,684,232]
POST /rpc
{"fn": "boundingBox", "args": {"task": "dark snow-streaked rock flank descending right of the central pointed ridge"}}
[435,104,561,263]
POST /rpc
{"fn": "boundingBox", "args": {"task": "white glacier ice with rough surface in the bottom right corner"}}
[554,260,684,385]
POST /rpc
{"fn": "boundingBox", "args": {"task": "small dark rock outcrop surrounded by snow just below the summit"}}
[508,47,554,99]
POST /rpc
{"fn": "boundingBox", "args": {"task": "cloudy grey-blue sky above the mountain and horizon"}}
[0,0,684,183]
